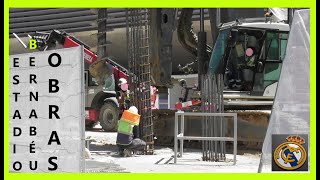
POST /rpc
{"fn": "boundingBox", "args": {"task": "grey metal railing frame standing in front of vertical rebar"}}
[174,111,237,165]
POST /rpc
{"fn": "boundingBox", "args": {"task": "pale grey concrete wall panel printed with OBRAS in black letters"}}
[9,47,85,172]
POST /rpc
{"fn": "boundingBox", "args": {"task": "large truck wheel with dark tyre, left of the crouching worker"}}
[99,102,119,132]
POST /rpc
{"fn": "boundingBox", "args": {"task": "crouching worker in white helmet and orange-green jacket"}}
[117,106,146,157]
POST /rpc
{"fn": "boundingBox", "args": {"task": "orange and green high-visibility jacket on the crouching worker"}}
[117,110,140,145]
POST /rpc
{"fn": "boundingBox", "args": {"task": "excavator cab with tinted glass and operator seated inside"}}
[209,21,289,96]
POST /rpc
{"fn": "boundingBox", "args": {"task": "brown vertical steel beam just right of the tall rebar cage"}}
[150,8,176,87]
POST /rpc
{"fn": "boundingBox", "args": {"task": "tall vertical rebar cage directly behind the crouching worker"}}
[126,9,154,154]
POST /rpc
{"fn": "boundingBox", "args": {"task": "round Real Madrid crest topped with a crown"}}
[273,135,307,170]
